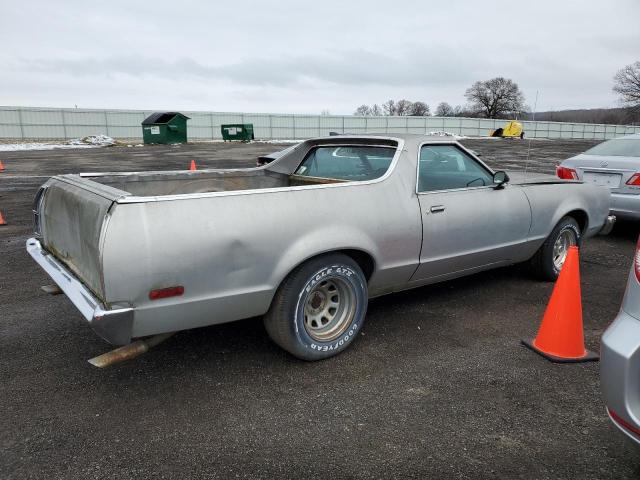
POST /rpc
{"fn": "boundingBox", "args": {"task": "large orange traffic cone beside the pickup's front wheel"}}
[522,246,598,363]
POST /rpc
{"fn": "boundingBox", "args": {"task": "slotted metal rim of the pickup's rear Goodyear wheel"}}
[304,278,356,342]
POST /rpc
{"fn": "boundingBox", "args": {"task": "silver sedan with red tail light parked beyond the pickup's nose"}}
[557,133,640,220]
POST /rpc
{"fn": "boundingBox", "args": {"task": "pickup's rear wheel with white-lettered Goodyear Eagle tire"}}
[264,254,368,360]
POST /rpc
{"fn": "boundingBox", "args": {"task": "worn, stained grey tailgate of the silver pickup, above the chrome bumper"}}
[35,176,125,301]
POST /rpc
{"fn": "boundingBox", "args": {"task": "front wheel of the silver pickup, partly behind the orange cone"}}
[530,216,581,281]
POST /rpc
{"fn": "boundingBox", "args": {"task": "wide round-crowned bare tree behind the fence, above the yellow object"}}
[464,77,524,118]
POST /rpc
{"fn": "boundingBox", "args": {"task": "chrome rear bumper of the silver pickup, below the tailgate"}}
[27,238,133,345]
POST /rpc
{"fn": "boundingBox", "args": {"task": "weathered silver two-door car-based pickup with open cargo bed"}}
[27,134,613,360]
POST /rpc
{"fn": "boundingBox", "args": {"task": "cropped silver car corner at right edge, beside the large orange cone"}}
[600,238,640,443]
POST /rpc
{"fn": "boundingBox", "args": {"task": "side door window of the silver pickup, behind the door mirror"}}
[418,145,493,192]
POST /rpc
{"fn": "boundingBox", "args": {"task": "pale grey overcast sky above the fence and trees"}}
[0,0,640,114]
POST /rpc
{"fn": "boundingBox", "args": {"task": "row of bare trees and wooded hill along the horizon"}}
[354,61,640,123]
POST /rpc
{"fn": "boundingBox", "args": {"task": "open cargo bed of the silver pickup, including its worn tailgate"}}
[34,168,340,301]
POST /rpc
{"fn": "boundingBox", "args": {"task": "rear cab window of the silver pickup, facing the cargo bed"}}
[294,145,396,180]
